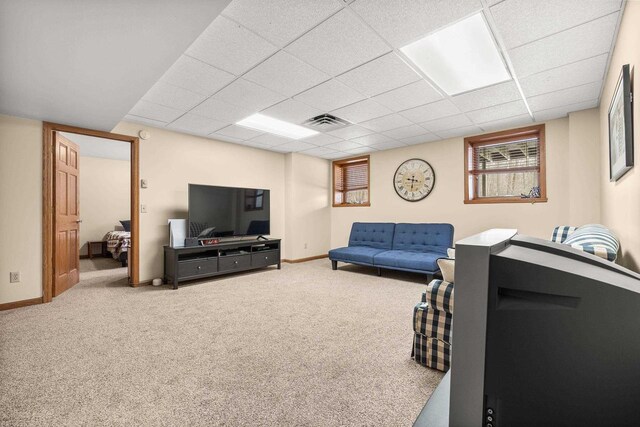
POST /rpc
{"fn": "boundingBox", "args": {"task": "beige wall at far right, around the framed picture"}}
[600,1,640,271]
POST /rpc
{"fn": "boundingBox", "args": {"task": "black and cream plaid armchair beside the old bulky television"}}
[411,279,453,372]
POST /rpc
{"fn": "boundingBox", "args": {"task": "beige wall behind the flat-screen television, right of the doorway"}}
[113,122,286,281]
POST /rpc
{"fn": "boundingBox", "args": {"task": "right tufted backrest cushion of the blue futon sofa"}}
[392,224,453,256]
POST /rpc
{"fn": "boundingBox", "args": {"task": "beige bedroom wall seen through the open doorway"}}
[80,157,131,255]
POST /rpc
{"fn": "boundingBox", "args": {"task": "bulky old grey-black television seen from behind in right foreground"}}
[449,230,640,427]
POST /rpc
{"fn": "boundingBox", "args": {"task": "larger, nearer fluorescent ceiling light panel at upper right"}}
[400,13,511,95]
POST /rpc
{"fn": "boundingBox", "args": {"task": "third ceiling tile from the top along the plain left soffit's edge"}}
[160,55,235,96]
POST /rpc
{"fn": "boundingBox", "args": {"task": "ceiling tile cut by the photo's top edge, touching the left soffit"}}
[222,0,341,47]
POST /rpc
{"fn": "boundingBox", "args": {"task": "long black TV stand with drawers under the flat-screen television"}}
[164,236,281,289]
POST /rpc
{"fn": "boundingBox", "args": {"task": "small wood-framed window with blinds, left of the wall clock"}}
[333,156,369,207]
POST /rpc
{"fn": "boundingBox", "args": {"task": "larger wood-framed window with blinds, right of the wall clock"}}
[464,125,547,203]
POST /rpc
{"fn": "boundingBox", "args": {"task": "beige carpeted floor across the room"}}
[0,259,442,426]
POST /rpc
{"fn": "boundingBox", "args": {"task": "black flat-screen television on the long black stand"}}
[189,184,271,238]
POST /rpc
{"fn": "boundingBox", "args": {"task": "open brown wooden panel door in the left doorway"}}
[53,132,80,297]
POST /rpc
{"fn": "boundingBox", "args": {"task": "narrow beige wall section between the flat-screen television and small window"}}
[286,153,331,260]
